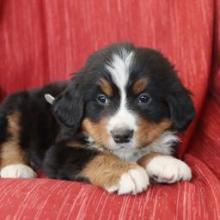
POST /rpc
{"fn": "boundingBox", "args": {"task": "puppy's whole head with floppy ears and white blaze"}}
[54,44,194,150]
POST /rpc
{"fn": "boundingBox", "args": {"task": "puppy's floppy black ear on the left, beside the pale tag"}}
[53,79,84,131]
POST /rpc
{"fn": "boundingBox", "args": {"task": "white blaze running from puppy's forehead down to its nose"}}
[106,49,137,139]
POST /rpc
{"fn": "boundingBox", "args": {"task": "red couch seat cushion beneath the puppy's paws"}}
[0,155,220,220]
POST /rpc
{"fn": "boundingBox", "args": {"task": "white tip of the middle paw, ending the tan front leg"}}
[106,167,149,195]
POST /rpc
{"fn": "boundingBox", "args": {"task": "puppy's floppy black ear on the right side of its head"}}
[167,87,195,131]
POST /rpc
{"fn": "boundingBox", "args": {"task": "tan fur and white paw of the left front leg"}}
[82,154,149,194]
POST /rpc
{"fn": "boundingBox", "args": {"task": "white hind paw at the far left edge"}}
[0,164,36,178]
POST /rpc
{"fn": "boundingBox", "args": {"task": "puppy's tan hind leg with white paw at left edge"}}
[0,113,36,178]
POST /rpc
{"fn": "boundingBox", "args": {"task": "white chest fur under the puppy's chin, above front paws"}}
[112,131,179,161]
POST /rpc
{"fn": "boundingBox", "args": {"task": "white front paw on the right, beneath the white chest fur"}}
[146,156,192,183]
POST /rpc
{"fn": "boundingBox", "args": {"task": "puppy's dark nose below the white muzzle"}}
[111,128,134,143]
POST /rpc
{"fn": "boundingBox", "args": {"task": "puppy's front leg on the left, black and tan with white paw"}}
[44,145,149,194]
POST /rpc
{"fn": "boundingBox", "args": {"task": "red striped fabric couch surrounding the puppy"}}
[0,0,220,220]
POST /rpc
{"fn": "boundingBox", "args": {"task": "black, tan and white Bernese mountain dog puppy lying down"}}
[0,43,195,194]
